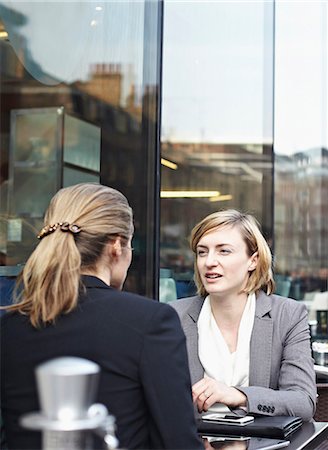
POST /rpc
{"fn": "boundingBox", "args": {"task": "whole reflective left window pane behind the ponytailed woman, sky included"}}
[0,0,161,295]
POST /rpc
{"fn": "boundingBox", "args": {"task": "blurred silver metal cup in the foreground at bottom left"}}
[20,357,118,450]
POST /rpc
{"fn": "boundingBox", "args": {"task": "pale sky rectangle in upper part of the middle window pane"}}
[162,1,273,142]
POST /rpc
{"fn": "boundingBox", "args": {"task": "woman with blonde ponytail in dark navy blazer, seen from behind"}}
[1,183,202,449]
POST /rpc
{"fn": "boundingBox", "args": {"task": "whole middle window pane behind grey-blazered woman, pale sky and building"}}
[160,2,273,301]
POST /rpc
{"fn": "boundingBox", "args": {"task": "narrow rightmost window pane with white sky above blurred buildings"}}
[275,1,328,312]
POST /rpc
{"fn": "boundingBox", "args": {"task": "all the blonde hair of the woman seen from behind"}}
[7,183,133,327]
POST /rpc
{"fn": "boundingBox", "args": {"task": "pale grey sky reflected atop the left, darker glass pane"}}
[0,0,144,102]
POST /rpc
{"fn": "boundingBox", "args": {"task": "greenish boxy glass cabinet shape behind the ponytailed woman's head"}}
[1,107,100,265]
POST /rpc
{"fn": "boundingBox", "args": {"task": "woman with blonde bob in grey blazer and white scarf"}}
[170,210,316,420]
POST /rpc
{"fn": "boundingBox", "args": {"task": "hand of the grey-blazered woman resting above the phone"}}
[192,378,247,412]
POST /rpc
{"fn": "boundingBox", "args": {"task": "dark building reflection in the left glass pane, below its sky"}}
[0,4,159,296]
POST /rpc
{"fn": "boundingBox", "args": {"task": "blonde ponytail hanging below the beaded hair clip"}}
[8,230,81,327]
